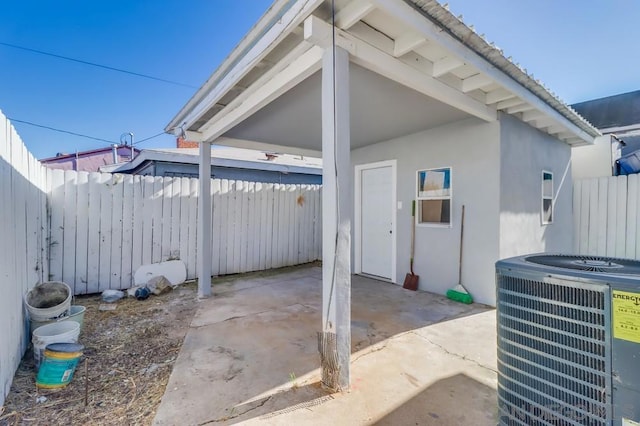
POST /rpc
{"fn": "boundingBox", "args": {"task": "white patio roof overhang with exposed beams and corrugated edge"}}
[166,0,599,150]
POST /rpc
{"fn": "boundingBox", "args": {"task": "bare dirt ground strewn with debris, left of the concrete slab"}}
[0,283,197,426]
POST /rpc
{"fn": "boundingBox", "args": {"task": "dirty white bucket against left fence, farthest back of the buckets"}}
[24,281,72,321]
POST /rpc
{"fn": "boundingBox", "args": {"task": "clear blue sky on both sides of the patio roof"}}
[0,0,640,158]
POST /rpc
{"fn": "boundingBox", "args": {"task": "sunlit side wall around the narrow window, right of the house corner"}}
[500,114,573,258]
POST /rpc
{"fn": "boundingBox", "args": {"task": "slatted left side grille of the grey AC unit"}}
[497,274,610,426]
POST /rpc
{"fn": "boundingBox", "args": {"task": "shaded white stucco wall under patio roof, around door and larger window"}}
[351,119,500,305]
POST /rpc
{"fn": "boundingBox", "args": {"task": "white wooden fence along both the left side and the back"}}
[0,113,322,406]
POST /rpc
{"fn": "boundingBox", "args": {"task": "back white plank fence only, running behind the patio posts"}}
[49,170,322,294]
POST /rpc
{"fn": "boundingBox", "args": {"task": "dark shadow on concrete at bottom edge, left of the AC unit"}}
[372,373,498,426]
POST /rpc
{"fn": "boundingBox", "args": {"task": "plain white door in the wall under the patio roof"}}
[359,165,395,279]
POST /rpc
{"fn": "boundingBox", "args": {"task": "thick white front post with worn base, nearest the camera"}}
[319,46,353,391]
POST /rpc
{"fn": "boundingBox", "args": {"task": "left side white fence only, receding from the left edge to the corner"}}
[0,112,48,407]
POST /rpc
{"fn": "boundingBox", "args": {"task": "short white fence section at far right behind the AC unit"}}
[573,175,640,259]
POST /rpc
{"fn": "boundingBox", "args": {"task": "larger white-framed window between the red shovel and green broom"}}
[417,167,451,225]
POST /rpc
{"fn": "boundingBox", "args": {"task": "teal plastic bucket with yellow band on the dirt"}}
[36,343,84,389]
